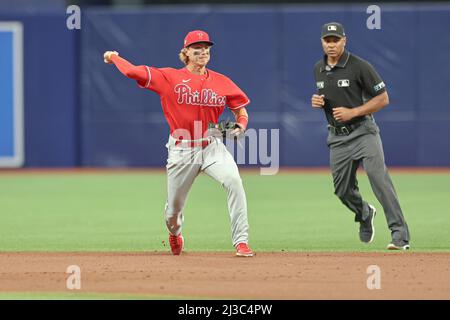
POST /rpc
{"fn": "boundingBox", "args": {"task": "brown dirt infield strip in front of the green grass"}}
[0,252,450,299]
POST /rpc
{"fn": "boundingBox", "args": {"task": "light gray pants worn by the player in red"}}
[164,136,249,246]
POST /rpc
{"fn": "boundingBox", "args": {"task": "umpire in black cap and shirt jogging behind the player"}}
[311,22,410,250]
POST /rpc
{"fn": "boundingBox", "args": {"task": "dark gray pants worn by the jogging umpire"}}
[327,119,409,242]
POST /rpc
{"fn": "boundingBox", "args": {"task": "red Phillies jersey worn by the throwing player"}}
[137,66,250,139]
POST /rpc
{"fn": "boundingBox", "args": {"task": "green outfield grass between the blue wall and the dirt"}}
[0,172,450,252]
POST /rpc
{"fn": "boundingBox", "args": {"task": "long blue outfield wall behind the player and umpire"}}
[0,4,450,167]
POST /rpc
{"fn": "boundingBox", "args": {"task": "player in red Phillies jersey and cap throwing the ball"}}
[103,30,253,257]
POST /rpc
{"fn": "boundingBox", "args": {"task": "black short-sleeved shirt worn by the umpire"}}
[314,51,386,127]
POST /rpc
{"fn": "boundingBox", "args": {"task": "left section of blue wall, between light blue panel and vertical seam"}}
[0,10,79,167]
